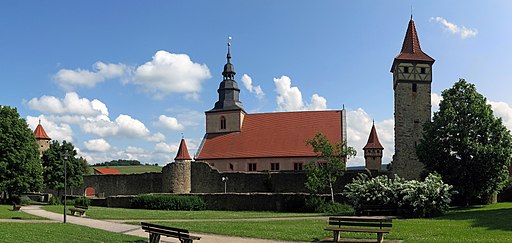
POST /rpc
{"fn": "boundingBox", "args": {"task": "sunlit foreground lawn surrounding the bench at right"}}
[149,203,512,242]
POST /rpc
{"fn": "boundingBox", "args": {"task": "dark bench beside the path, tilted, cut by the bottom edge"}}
[140,222,201,243]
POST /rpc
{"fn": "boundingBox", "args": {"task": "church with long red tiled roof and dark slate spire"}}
[195,40,346,171]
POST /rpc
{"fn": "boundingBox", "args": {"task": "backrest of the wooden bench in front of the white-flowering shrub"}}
[329,217,393,229]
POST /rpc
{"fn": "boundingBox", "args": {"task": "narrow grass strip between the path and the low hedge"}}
[42,205,321,220]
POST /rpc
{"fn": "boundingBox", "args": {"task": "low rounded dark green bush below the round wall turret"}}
[130,194,206,211]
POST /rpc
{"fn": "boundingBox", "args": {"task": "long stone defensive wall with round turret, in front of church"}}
[77,162,388,197]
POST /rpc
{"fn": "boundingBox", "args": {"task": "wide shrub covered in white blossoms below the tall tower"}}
[344,174,453,217]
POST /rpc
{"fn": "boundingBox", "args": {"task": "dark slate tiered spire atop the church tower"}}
[211,37,243,111]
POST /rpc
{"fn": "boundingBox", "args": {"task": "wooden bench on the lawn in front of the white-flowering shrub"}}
[325,216,393,243]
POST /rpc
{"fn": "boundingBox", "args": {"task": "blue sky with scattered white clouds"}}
[0,1,512,165]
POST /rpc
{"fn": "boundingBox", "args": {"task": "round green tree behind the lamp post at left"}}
[42,141,87,195]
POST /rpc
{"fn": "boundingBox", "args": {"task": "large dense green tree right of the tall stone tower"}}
[417,79,512,205]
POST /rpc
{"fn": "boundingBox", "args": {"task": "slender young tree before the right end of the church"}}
[305,133,356,203]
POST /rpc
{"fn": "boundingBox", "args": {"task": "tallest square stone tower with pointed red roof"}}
[391,16,435,179]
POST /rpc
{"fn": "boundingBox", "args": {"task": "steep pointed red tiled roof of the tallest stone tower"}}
[391,18,435,71]
